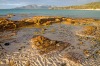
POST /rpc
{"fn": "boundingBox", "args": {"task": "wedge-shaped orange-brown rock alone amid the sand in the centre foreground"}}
[31,36,70,54]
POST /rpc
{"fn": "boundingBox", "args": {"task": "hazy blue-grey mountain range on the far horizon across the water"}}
[14,5,51,9]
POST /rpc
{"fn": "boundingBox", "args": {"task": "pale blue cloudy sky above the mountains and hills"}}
[0,0,100,9]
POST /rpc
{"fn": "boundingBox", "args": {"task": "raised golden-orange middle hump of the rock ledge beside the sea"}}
[21,16,63,25]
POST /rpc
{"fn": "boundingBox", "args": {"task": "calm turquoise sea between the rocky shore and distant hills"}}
[0,9,100,19]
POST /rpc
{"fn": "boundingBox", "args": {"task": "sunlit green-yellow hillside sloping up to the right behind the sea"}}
[50,2,100,9]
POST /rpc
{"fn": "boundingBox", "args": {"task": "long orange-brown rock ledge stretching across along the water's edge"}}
[0,14,96,31]
